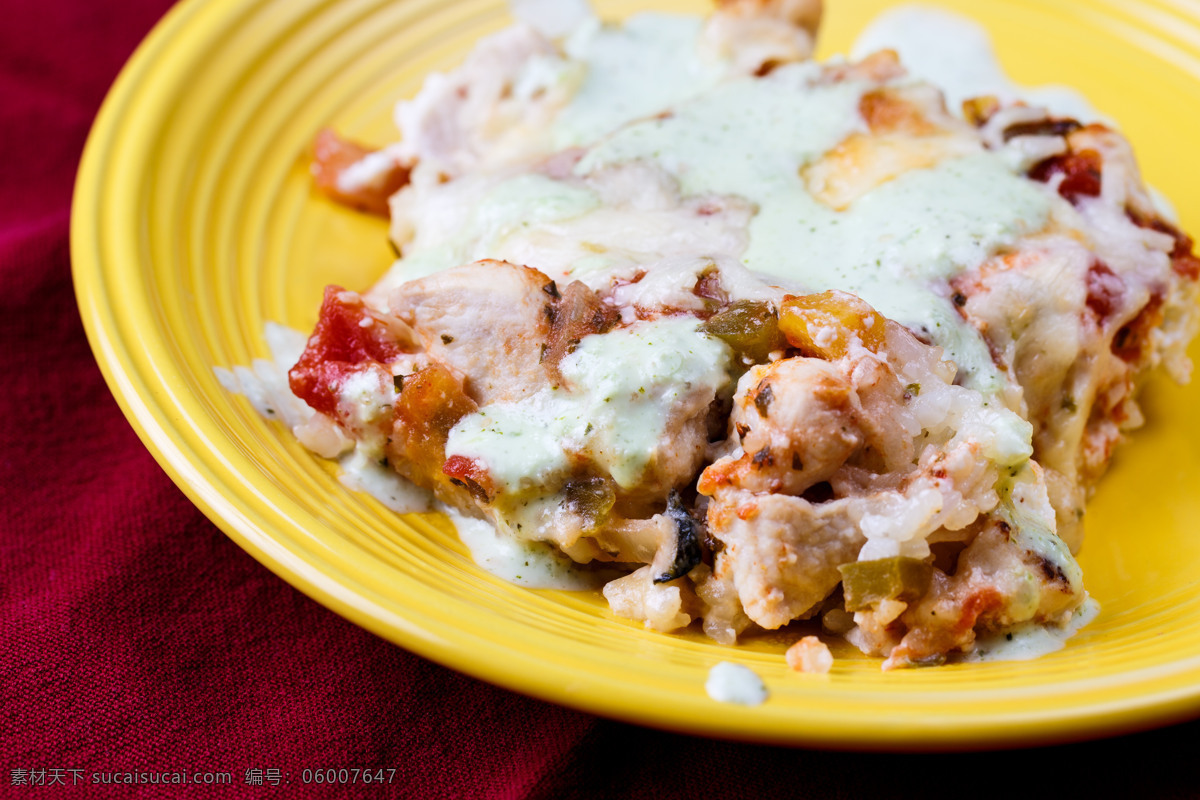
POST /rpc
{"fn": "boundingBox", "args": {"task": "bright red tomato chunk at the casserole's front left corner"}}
[288,285,403,419]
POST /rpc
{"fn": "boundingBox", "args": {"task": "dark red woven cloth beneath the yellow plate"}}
[7,0,1200,800]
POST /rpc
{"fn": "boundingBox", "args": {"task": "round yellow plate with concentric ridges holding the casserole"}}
[71,0,1200,748]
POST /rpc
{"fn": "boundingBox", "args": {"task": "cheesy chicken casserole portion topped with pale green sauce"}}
[255,0,1200,672]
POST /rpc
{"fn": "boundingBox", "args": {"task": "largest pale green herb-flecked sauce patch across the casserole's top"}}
[576,64,1050,391]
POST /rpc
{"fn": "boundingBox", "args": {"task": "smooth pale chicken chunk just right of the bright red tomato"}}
[389,260,558,405]
